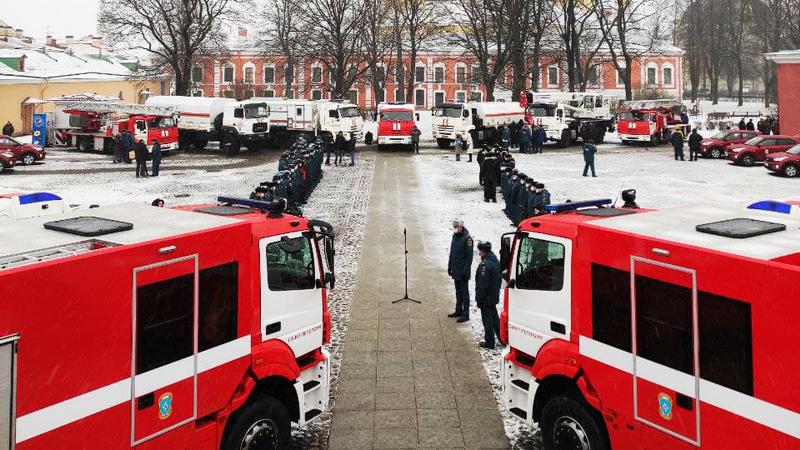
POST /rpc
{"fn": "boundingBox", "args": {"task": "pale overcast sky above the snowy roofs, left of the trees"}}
[0,0,98,39]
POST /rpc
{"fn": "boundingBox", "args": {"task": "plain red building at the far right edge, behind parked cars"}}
[767,50,800,135]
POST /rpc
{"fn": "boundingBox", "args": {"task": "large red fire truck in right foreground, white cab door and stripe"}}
[501,200,800,450]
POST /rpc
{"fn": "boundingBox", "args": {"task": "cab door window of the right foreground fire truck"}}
[516,237,565,291]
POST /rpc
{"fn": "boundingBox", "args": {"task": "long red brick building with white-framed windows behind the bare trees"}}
[193,46,684,109]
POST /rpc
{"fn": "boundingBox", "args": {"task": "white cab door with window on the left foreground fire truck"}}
[259,232,322,356]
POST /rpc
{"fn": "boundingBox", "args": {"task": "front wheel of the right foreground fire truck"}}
[539,395,609,450]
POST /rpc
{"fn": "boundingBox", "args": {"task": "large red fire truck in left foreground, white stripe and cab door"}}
[0,198,334,450]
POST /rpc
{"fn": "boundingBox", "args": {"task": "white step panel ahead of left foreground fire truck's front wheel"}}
[294,348,331,427]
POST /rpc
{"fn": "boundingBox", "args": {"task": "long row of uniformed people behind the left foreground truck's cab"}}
[250,136,324,215]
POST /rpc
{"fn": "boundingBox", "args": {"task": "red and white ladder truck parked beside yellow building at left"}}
[53,100,178,152]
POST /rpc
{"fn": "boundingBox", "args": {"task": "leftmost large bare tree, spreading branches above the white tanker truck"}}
[98,0,233,95]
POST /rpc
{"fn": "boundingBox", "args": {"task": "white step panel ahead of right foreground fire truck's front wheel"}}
[501,348,539,426]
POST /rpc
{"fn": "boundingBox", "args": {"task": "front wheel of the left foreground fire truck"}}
[222,396,292,450]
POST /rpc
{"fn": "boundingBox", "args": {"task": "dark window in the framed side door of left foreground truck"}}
[135,274,194,374]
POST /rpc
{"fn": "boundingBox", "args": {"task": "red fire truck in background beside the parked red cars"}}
[617,99,691,145]
